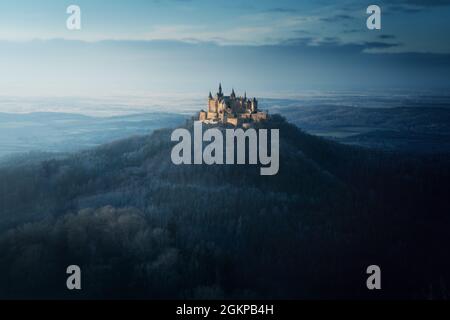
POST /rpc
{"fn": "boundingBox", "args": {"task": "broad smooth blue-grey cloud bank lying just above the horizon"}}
[0,36,450,96]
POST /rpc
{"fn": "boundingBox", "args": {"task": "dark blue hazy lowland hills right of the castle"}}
[262,101,450,154]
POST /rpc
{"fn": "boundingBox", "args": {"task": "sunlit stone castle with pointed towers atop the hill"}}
[199,84,268,127]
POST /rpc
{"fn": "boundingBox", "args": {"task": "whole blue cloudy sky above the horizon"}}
[0,0,450,96]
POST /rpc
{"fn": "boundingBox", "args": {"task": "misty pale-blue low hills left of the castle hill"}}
[0,112,187,159]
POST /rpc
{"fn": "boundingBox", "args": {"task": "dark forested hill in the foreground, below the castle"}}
[0,115,450,298]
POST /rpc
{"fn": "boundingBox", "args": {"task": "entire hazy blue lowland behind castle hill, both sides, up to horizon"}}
[4,92,450,160]
